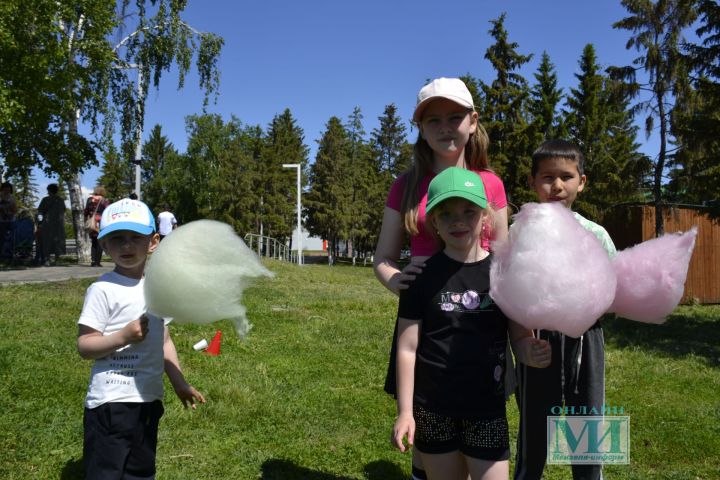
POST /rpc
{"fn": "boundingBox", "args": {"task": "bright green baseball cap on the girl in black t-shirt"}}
[425,167,487,213]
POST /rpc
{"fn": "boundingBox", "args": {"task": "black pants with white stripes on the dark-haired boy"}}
[514,322,605,480]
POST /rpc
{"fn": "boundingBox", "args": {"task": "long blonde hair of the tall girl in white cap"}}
[400,120,490,236]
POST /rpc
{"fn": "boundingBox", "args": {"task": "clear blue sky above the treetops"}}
[38,0,668,202]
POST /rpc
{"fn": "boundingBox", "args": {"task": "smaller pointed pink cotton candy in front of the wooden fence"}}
[610,227,697,323]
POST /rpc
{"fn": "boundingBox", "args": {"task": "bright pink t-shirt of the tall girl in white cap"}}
[385,170,507,257]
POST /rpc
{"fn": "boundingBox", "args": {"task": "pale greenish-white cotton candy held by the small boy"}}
[145,220,273,337]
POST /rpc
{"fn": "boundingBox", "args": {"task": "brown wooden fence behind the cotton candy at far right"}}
[603,204,720,304]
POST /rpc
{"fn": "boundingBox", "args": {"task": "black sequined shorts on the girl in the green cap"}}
[413,404,510,461]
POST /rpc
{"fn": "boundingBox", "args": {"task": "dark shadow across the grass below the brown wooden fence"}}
[603,308,720,367]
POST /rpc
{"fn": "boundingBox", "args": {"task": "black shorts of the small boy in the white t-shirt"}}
[83,400,164,480]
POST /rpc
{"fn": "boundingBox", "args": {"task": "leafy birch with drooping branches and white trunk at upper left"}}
[0,0,223,261]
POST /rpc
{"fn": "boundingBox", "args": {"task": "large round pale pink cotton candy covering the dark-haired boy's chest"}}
[490,203,616,337]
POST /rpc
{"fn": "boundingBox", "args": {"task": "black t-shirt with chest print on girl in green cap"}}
[398,252,507,419]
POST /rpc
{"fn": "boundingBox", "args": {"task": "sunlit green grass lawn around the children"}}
[0,261,720,480]
